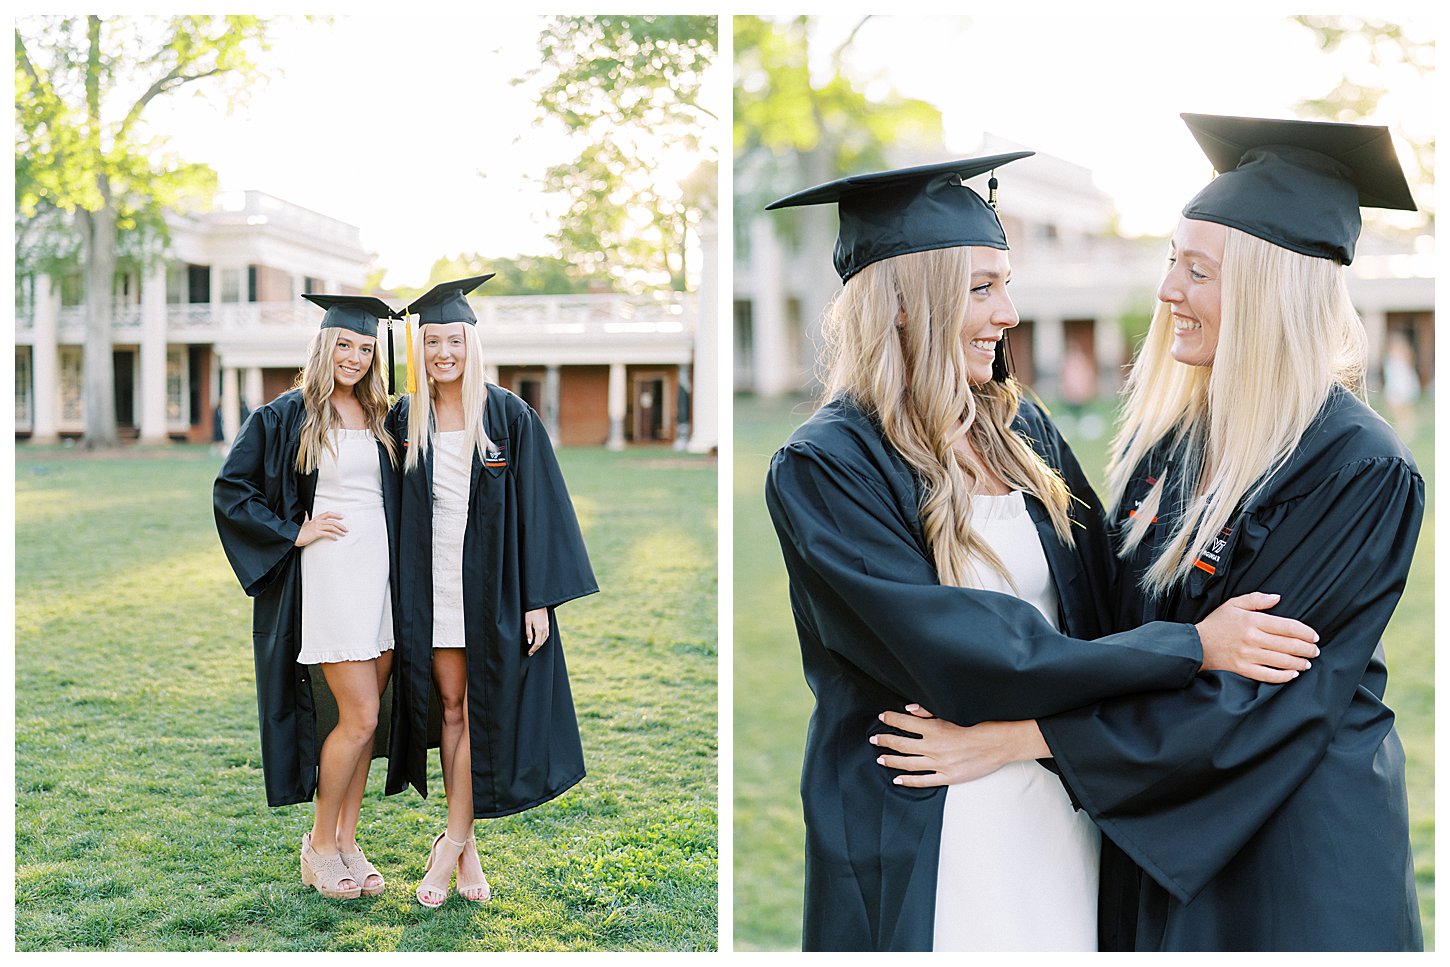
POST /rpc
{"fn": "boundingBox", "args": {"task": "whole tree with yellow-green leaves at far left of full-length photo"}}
[15,14,268,447]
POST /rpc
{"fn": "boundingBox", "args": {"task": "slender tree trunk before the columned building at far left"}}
[77,206,117,449]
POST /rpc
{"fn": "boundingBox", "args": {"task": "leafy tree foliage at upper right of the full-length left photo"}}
[521,16,719,291]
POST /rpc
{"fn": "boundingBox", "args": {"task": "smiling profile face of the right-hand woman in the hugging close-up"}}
[1159,219,1228,365]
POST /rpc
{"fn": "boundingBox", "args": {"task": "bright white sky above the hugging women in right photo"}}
[812,14,1436,233]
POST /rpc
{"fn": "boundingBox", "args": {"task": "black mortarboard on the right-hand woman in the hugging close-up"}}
[1179,115,1415,265]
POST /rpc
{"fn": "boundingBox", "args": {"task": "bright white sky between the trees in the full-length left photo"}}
[139,14,664,286]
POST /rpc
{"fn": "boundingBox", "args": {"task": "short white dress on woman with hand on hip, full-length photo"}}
[297,429,393,665]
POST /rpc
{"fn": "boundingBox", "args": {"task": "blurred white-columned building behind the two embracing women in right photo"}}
[734,135,1434,402]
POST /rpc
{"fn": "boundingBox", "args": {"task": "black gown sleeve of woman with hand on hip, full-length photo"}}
[212,406,302,597]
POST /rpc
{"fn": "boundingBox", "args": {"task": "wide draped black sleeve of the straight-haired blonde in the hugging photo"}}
[1038,458,1424,902]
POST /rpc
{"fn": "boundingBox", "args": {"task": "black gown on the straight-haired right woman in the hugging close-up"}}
[1040,389,1424,950]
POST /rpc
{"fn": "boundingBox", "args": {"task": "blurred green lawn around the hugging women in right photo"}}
[734,397,1436,950]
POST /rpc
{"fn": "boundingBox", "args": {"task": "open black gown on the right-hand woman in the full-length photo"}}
[387,384,599,819]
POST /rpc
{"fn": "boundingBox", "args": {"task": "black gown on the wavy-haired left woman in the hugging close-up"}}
[766,399,1202,950]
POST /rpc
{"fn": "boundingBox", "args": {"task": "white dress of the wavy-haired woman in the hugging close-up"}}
[934,491,1101,951]
